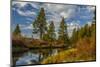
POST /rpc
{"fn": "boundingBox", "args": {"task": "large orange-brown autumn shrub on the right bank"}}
[76,37,96,61]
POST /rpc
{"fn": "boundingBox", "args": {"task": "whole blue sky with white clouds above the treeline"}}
[11,1,95,37]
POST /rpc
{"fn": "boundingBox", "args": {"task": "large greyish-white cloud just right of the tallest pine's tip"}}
[42,4,77,18]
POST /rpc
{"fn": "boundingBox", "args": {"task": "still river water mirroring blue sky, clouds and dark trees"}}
[15,49,62,65]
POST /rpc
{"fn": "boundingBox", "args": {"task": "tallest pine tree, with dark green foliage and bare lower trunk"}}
[33,8,47,39]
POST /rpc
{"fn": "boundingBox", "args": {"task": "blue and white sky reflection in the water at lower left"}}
[16,52,42,65]
